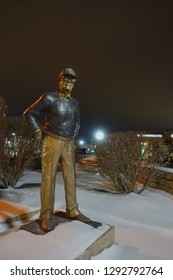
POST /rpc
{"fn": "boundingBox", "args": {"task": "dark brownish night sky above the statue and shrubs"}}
[0,0,173,140]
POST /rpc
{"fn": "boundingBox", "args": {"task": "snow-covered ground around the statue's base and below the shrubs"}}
[0,165,173,260]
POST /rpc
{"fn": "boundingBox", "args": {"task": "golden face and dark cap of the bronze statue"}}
[58,68,76,94]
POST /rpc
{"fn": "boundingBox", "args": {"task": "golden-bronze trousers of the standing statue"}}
[40,135,78,218]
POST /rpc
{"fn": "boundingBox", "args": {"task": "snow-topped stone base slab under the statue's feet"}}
[0,215,115,260]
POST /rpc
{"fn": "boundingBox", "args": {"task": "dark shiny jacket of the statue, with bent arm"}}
[24,91,80,140]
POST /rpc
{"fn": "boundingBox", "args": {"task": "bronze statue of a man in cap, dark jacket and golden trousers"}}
[24,68,90,232]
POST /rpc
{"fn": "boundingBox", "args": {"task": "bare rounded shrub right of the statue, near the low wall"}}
[95,131,169,193]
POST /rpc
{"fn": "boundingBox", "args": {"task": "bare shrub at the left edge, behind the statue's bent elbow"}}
[0,117,36,188]
